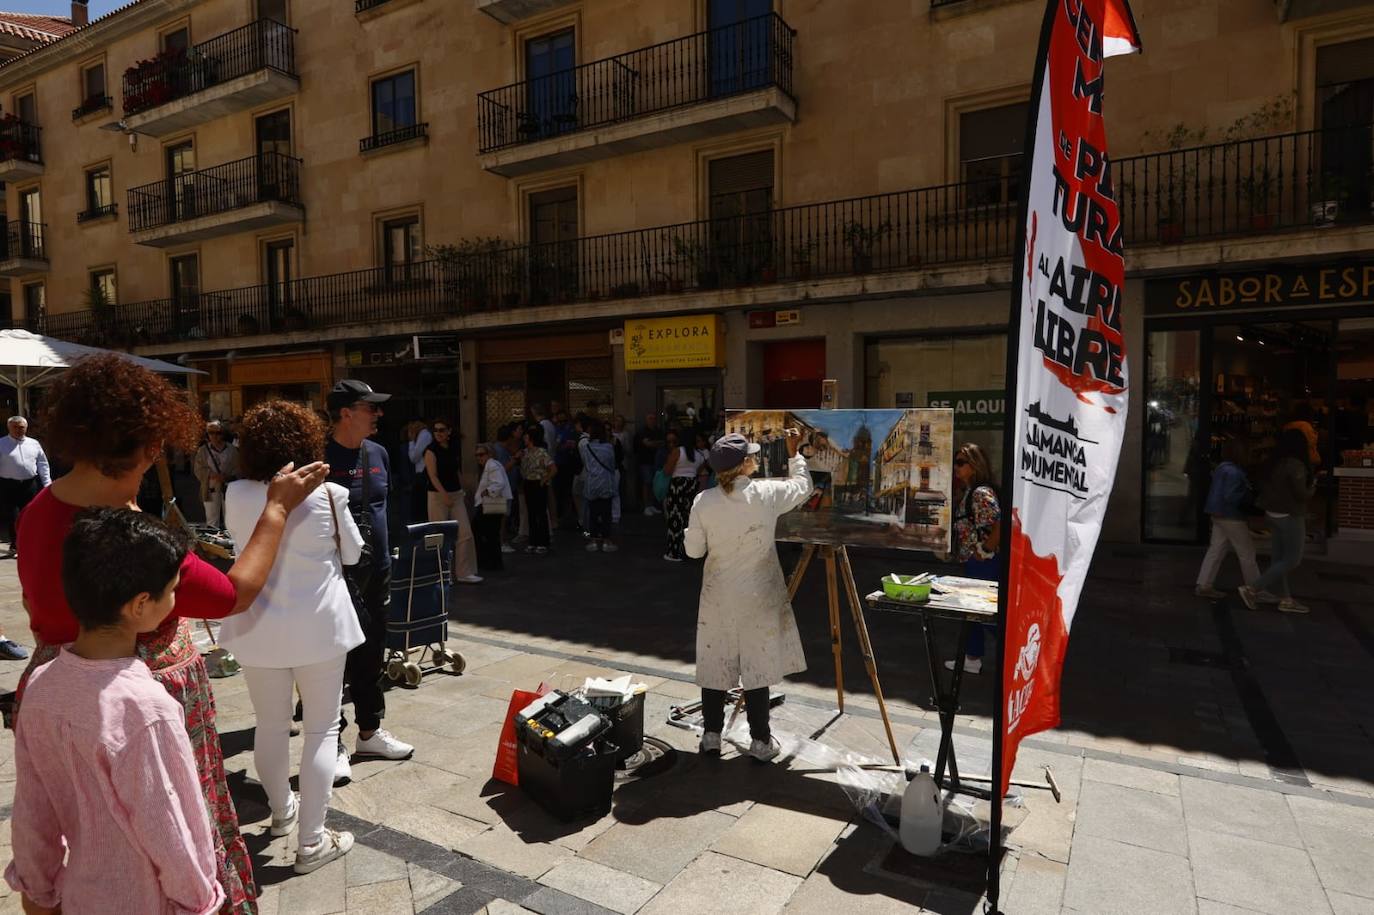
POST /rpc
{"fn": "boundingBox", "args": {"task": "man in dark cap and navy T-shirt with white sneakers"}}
[324,378,415,784]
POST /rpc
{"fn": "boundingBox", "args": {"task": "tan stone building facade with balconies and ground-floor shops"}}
[0,0,1374,541]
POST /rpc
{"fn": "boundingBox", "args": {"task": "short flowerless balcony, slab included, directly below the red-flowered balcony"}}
[126,153,305,247]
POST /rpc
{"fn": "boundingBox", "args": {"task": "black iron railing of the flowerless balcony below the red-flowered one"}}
[128,153,301,232]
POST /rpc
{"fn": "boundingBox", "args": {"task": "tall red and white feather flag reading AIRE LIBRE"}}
[1000,0,1140,794]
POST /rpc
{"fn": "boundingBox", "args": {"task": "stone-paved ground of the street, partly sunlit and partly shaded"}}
[0,518,1374,915]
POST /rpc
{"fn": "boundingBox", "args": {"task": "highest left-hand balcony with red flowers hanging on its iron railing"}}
[124,19,301,136]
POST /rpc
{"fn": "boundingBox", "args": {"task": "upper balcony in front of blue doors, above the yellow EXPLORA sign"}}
[477,14,797,176]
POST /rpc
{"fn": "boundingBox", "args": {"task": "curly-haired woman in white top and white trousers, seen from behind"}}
[220,400,363,874]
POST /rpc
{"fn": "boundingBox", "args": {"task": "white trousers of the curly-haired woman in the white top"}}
[243,654,348,848]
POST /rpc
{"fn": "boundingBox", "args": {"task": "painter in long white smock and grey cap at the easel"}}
[684,430,811,763]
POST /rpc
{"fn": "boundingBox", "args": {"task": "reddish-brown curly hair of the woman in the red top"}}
[41,354,205,477]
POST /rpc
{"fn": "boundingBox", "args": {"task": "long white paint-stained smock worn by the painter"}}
[684,455,811,690]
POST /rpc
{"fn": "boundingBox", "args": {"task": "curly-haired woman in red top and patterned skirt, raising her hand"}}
[16,354,328,915]
